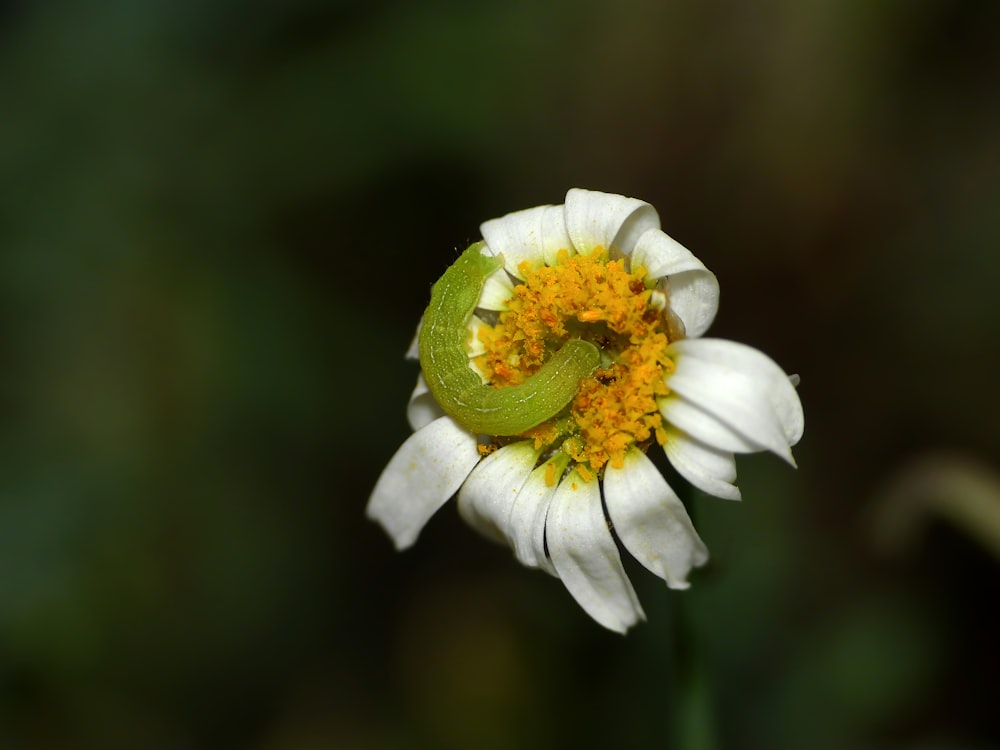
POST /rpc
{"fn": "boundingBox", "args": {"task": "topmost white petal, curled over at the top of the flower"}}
[566,188,660,254]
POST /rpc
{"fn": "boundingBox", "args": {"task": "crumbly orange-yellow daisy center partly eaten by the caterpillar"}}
[473,247,679,481]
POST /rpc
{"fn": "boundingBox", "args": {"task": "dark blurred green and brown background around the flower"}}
[0,0,1000,750]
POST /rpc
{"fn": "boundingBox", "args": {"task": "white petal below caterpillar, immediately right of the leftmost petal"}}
[458,440,539,546]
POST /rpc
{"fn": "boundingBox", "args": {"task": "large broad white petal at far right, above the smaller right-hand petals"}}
[669,339,804,465]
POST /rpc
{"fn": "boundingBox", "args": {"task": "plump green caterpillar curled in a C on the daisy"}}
[420,242,601,435]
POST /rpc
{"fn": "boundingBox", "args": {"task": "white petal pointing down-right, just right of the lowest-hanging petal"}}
[604,448,708,589]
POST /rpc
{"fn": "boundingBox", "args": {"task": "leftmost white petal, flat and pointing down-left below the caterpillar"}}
[366,417,480,549]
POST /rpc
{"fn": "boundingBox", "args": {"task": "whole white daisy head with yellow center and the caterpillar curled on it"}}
[367,189,803,633]
